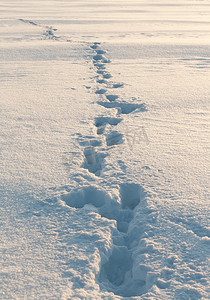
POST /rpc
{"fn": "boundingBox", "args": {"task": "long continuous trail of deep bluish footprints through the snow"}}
[58,42,149,297]
